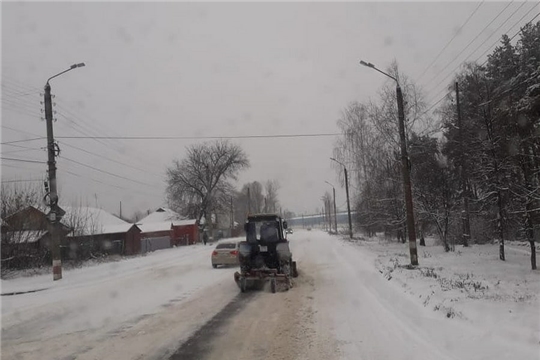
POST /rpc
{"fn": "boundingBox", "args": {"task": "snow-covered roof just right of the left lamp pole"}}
[60,206,133,237]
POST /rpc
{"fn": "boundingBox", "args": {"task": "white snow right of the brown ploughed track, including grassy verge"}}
[295,232,540,360]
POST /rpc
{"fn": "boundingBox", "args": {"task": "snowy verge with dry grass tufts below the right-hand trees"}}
[356,238,540,344]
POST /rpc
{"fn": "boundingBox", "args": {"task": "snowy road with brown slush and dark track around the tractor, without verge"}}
[2,231,540,360]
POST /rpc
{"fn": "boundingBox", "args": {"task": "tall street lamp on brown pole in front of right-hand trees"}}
[360,60,418,265]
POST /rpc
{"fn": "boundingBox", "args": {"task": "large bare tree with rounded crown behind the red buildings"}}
[167,140,249,238]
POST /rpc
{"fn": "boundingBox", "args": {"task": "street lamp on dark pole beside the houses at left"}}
[44,63,84,280]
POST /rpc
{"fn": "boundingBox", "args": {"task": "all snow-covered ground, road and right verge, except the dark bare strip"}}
[1,230,540,360]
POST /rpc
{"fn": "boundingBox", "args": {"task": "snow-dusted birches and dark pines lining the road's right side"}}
[334,23,540,268]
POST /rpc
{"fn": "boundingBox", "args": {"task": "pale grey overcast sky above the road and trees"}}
[2,2,538,215]
